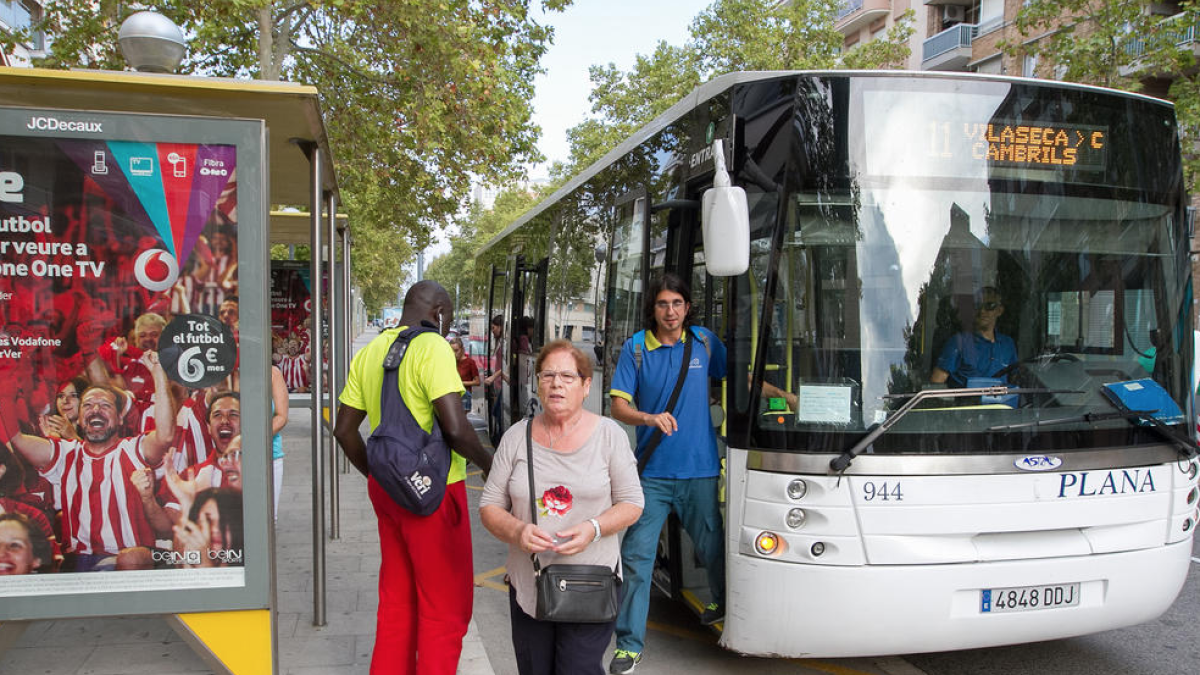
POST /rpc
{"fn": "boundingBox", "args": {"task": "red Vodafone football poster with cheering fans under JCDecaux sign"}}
[0,110,265,604]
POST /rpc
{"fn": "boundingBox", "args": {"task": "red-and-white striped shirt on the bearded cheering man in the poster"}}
[41,436,155,555]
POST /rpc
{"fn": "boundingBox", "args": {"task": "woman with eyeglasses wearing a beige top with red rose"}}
[480,340,642,675]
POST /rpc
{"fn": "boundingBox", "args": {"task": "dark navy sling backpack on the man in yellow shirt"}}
[367,327,450,515]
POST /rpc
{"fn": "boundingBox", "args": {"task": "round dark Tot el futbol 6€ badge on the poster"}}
[158,315,238,389]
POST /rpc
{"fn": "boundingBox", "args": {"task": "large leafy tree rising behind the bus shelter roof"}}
[10,0,571,307]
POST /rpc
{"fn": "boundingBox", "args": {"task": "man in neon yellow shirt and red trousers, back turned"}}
[334,281,492,675]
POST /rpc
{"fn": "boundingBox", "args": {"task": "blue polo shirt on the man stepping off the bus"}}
[608,325,725,478]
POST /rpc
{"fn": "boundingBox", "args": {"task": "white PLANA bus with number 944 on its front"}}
[476,72,1200,657]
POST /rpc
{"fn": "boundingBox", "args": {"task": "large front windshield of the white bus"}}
[731,78,1192,453]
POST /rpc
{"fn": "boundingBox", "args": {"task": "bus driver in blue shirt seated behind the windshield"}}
[929,286,1016,387]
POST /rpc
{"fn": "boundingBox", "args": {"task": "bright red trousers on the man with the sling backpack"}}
[367,478,474,675]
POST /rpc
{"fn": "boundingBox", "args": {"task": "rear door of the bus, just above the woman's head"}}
[505,256,550,420]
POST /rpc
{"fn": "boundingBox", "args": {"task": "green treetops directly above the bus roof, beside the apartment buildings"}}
[551,0,914,179]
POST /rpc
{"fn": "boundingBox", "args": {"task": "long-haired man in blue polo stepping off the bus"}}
[608,274,725,674]
